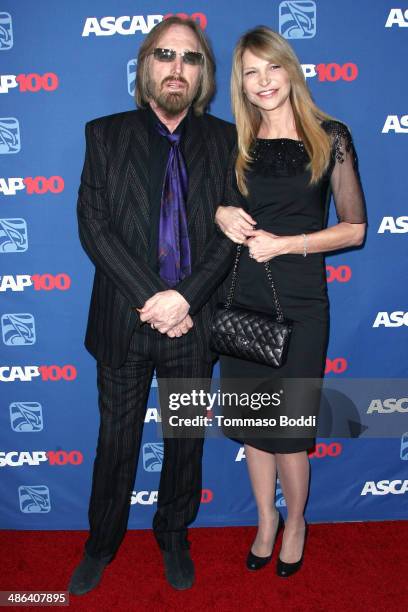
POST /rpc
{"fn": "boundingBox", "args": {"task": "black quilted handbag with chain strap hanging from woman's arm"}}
[210,244,293,368]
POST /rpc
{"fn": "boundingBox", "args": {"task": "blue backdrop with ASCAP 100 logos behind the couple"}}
[0,0,408,529]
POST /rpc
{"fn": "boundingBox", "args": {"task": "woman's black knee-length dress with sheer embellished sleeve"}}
[220,121,366,453]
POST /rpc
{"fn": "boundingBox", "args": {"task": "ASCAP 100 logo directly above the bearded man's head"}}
[82,13,207,37]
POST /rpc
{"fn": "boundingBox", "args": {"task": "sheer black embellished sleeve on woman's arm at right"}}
[328,121,367,223]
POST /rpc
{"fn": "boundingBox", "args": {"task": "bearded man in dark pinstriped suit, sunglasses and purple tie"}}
[69,17,235,595]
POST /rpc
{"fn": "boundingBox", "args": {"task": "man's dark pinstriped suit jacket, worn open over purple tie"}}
[77,110,236,367]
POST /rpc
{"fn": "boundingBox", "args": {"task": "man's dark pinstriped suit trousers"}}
[85,325,212,560]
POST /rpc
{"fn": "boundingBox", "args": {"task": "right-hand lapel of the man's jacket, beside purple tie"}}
[184,113,206,230]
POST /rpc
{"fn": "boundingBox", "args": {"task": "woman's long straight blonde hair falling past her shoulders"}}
[231,26,332,196]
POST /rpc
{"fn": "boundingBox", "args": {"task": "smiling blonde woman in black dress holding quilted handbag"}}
[216,27,366,576]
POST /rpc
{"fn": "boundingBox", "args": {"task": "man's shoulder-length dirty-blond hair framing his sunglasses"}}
[135,16,215,115]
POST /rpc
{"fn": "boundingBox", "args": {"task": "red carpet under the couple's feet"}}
[0,521,408,612]
